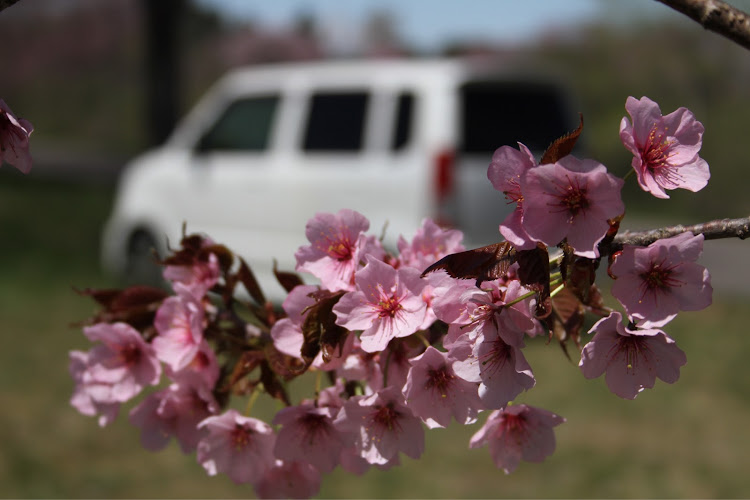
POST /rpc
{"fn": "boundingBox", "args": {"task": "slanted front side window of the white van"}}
[198,96,279,152]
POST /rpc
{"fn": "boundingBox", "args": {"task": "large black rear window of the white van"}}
[461,81,571,154]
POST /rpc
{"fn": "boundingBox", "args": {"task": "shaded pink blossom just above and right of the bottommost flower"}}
[273,403,344,473]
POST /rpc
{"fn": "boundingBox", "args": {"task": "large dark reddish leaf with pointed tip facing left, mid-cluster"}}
[422,241,520,286]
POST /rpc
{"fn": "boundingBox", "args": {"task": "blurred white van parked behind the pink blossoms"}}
[103,60,578,299]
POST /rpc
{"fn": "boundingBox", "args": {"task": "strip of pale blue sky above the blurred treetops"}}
[197,0,681,51]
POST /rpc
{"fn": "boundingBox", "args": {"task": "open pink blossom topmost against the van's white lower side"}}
[294,209,385,291]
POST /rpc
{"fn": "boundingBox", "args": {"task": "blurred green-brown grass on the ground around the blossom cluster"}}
[0,175,750,498]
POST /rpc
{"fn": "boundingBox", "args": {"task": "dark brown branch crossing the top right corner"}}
[656,0,750,49]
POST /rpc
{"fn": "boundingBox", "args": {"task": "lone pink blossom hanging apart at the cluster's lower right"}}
[469,404,565,474]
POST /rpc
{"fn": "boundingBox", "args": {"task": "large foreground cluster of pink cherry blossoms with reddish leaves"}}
[70,98,712,498]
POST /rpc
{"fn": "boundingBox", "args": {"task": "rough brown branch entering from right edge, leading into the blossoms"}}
[599,217,750,256]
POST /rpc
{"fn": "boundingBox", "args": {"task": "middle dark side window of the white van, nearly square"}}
[302,92,369,152]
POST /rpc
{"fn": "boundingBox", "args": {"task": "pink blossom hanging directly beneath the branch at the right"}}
[611,232,713,328]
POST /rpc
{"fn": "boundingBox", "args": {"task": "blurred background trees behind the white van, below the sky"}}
[0,0,750,219]
